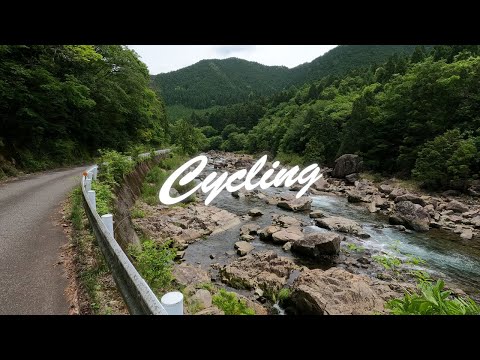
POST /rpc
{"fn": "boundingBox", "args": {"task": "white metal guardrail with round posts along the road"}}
[81,150,183,315]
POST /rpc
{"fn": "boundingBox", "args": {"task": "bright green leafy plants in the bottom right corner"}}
[386,280,480,315]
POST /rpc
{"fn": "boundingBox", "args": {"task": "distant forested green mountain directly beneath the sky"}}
[151,45,415,109]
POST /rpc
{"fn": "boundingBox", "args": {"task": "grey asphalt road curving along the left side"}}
[0,166,86,314]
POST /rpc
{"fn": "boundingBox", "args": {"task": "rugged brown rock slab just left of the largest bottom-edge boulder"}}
[220,251,298,294]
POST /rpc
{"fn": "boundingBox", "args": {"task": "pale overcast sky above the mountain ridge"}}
[128,45,336,75]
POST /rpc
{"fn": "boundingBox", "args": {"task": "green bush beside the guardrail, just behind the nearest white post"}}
[129,240,176,293]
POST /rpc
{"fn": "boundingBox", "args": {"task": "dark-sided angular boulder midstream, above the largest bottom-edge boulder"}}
[292,232,345,258]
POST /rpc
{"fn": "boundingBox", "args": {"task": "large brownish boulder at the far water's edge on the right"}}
[389,201,430,231]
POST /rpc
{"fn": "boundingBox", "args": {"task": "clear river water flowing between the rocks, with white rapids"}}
[185,162,480,299]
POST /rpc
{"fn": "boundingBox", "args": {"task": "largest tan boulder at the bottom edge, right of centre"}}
[291,268,399,315]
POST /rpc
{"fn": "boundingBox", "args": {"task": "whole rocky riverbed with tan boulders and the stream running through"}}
[130,152,480,314]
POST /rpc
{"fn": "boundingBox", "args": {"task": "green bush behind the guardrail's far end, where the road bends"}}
[98,150,135,186]
